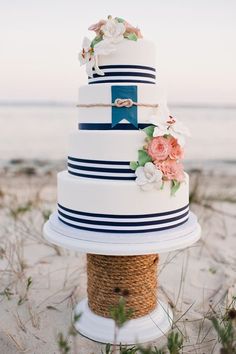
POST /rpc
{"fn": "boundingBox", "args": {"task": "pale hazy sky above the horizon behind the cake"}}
[0,0,236,104]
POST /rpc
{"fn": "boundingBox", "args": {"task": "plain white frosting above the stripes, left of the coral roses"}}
[69,130,146,161]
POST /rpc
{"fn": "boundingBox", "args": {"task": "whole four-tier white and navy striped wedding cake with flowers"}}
[58,16,189,234]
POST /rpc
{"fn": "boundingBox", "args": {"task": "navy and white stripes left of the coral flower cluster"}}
[68,156,136,181]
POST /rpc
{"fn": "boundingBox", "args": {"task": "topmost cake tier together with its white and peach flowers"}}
[79,16,156,84]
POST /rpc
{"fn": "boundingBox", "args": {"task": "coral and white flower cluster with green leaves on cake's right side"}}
[130,116,189,195]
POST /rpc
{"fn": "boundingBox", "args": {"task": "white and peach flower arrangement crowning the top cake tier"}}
[79,16,142,77]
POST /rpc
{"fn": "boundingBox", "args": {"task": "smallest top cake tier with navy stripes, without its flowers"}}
[88,39,156,84]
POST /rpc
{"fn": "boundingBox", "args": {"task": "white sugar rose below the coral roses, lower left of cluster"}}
[135,162,163,191]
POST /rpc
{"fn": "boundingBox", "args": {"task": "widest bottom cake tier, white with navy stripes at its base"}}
[58,171,189,233]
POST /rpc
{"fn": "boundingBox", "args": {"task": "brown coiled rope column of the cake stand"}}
[87,254,159,318]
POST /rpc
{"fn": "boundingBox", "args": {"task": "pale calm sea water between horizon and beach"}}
[0,104,236,161]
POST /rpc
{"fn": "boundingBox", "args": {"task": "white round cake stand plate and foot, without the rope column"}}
[44,212,201,344]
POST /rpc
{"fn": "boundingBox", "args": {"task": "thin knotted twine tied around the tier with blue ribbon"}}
[77,98,159,108]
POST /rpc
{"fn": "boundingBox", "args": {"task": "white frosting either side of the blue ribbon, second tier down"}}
[78,83,169,123]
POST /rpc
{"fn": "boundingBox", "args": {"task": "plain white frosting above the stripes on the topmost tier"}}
[98,39,156,68]
